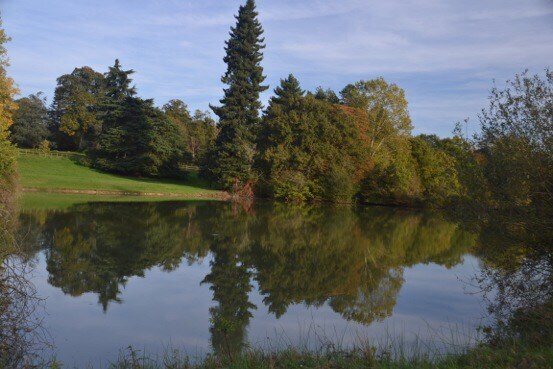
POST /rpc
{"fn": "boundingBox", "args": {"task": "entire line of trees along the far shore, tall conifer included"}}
[0,0,553,206]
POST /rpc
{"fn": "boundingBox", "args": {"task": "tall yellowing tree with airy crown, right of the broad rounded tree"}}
[341,78,422,205]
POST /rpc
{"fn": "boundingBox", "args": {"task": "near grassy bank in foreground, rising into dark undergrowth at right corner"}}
[41,302,553,369]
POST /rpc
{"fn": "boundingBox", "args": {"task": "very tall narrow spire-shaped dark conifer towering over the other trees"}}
[203,0,269,189]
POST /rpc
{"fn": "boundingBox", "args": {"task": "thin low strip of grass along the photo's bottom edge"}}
[41,345,553,369]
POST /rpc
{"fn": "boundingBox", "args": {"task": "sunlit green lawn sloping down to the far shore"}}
[18,155,220,195]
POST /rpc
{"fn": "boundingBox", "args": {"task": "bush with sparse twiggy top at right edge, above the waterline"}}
[477,69,553,209]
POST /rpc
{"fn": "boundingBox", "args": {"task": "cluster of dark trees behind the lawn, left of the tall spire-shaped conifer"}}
[11,60,216,177]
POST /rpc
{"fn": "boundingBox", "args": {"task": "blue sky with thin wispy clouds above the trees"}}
[0,0,553,136]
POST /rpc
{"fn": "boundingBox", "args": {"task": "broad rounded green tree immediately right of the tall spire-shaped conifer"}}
[257,90,356,201]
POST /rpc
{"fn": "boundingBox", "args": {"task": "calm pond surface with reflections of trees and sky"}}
[15,195,483,367]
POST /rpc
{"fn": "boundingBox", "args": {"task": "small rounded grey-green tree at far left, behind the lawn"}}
[10,92,49,149]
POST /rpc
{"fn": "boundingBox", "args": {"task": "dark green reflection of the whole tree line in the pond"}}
[16,202,476,352]
